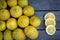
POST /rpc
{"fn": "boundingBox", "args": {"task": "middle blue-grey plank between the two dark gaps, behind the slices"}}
[34,11,60,29]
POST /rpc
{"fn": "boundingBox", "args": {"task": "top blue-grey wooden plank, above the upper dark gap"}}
[29,0,60,10]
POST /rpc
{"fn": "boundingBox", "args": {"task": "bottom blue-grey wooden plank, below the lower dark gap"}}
[26,30,60,40]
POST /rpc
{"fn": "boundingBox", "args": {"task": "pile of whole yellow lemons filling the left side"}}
[0,0,41,40]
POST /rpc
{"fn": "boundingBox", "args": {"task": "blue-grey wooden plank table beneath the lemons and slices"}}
[26,0,60,40]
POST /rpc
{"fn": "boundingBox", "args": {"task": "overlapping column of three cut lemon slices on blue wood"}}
[44,12,56,35]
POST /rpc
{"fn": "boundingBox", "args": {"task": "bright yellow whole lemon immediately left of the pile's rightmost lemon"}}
[18,15,29,28]
